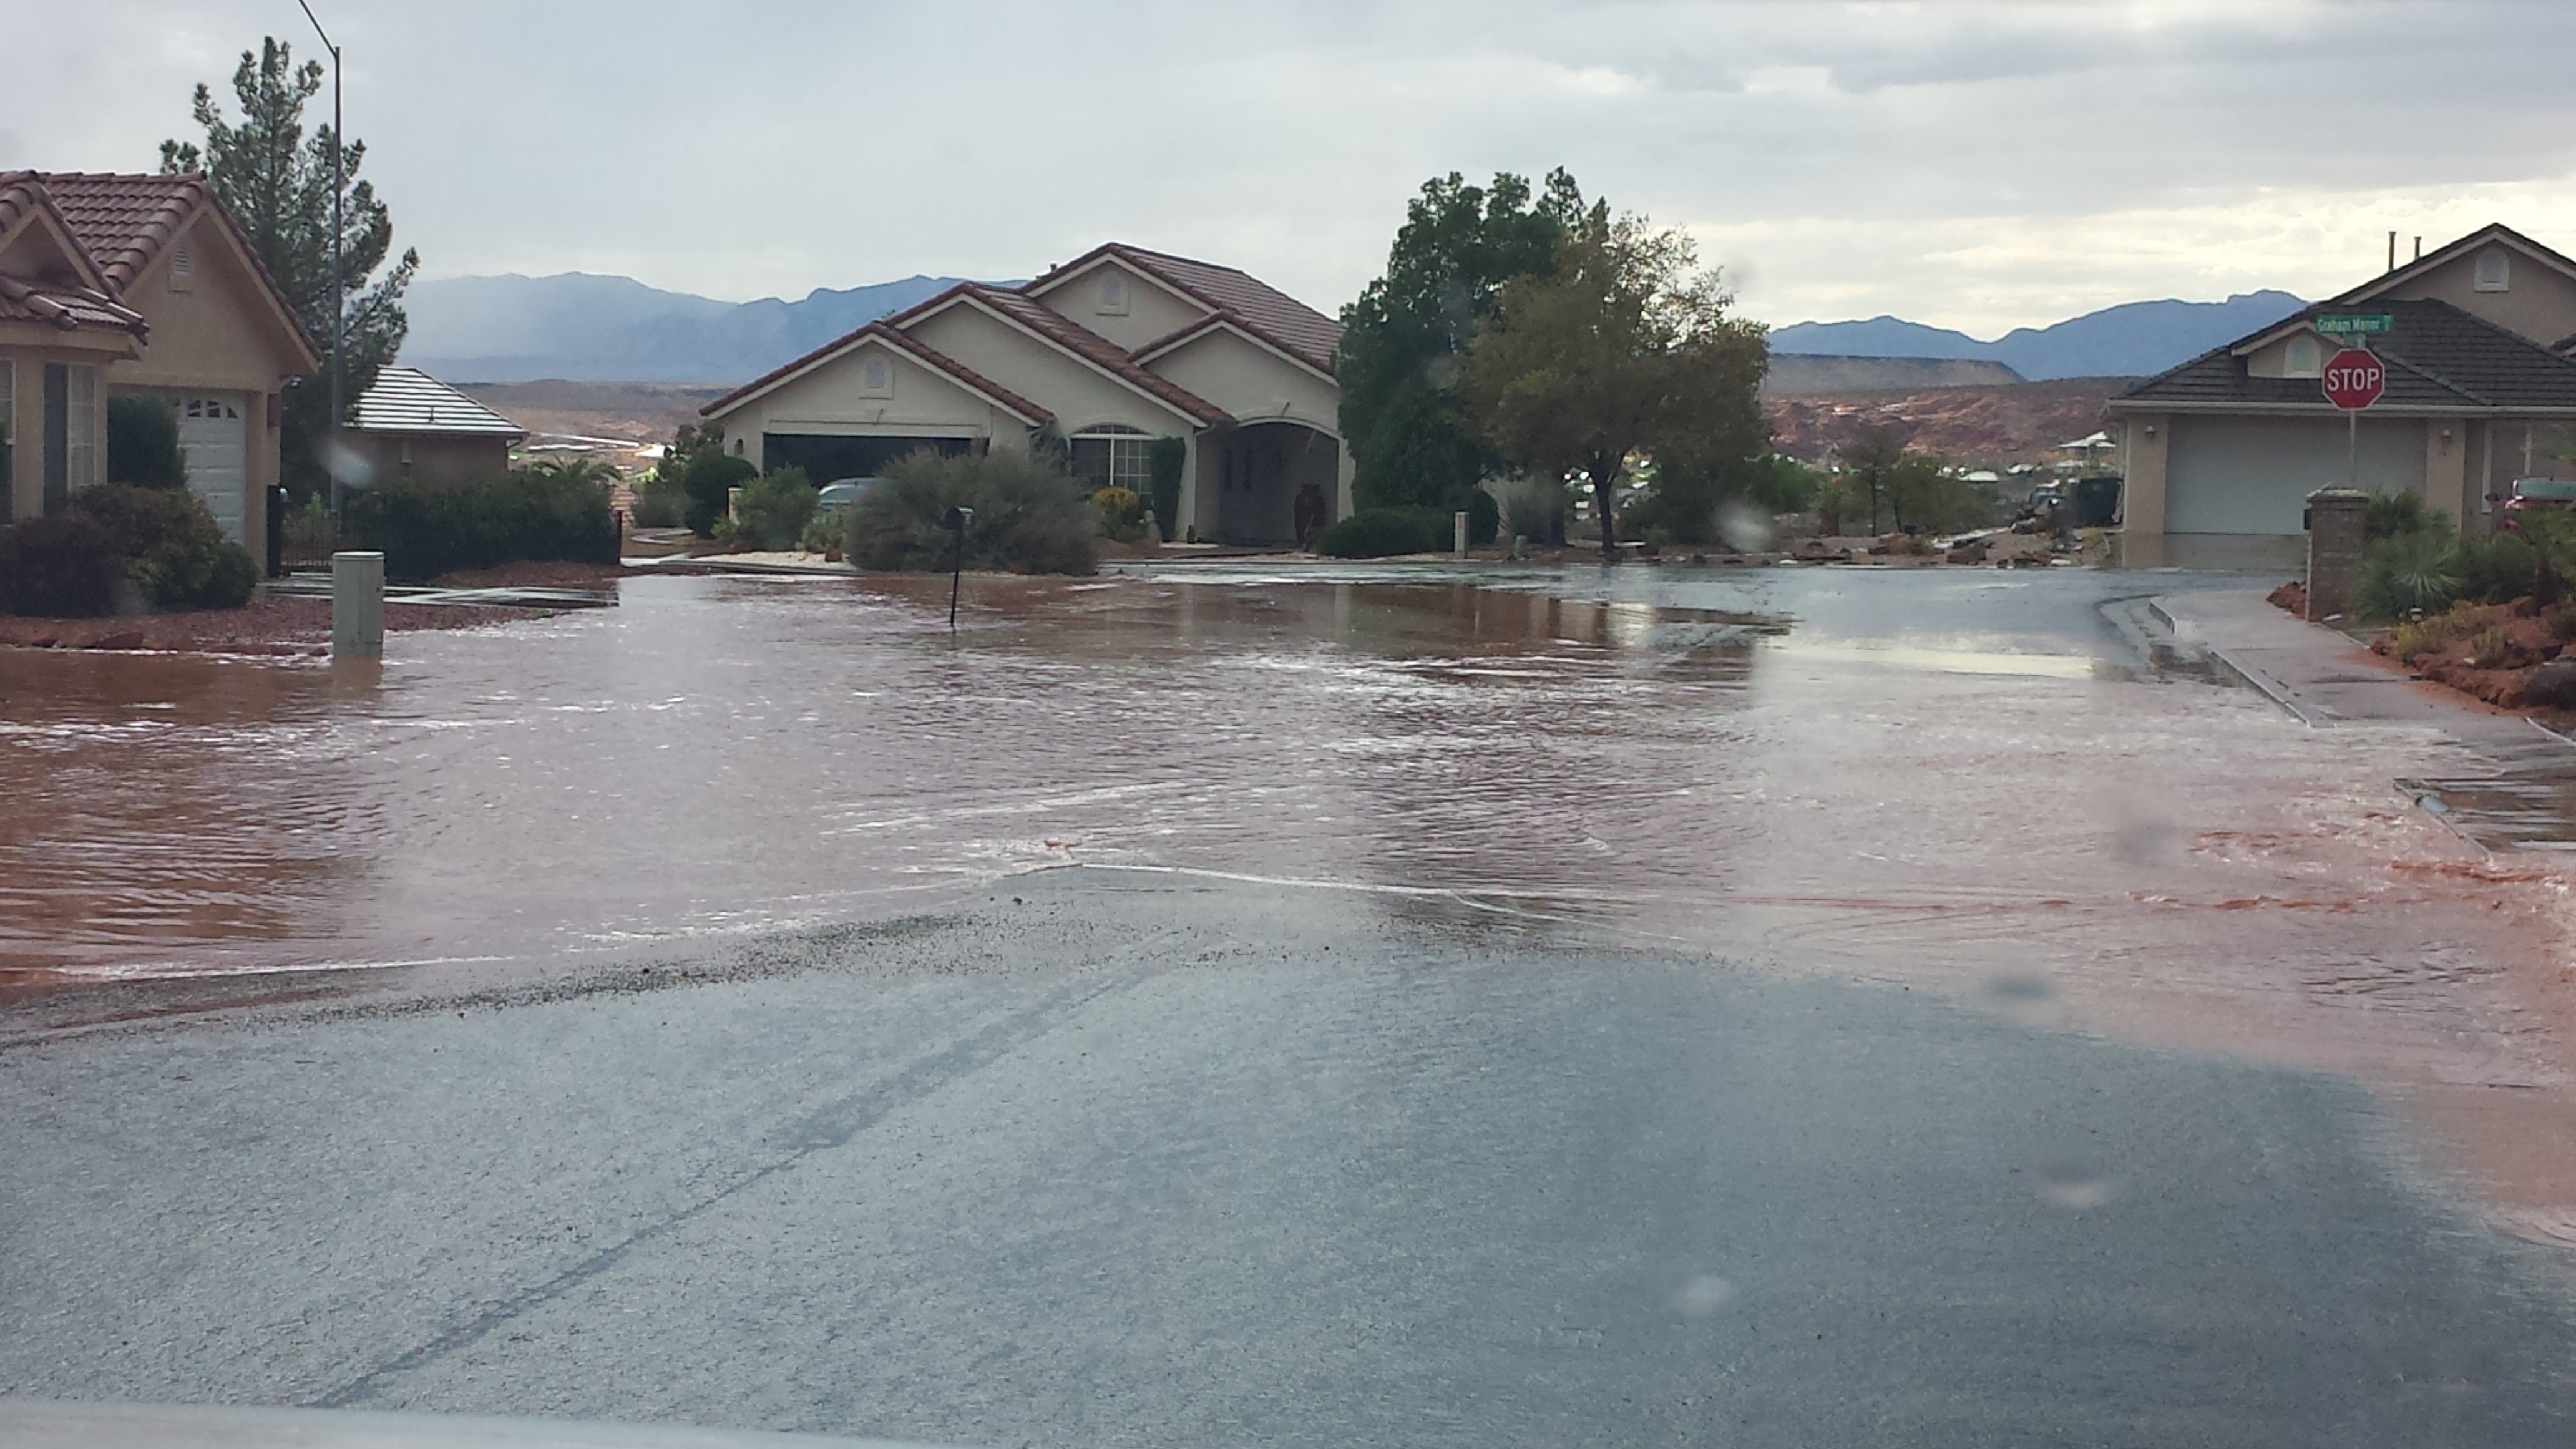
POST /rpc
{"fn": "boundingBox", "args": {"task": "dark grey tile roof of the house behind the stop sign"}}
[2112,299,2576,415]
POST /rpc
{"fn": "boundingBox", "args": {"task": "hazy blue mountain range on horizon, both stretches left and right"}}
[402,271,2303,384]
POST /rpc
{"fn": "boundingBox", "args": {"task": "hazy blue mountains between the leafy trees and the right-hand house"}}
[1770,291,2306,381]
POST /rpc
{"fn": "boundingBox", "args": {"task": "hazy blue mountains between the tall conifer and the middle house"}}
[402,271,978,381]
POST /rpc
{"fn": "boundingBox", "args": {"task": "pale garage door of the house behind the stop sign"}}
[2164,417,2424,534]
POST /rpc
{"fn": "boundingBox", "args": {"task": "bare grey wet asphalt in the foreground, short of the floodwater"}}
[0,872,2576,1447]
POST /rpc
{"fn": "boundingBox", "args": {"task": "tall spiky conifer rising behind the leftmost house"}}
[162,36,420,495]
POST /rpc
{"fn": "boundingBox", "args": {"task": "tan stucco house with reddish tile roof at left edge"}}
[0,170,322,544]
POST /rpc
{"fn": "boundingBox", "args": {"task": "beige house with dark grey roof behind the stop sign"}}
[2107,227,2576,562]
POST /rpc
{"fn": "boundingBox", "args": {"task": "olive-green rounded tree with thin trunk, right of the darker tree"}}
[1458,201,1770,560]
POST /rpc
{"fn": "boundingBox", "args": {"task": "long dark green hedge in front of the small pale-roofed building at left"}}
[348,469,618,580]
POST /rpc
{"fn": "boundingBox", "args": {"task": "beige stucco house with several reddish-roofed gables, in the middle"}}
[703,242,1352,544]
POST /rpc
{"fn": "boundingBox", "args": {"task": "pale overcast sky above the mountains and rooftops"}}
[15,0,2576,335]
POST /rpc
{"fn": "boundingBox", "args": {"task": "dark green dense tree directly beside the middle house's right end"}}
[1337,170,1584,510]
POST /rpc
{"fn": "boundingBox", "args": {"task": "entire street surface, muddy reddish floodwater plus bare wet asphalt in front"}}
[0,565,2576,1444]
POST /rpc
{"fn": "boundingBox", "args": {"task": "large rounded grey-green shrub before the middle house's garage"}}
[847,449,1100,572]
